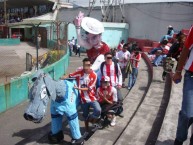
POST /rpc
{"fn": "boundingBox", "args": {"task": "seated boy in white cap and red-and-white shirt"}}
[97,76,117,126]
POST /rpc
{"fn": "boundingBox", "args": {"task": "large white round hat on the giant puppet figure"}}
[81,17,104,34]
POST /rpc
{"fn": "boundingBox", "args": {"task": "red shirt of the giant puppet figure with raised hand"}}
[86,42,110,64]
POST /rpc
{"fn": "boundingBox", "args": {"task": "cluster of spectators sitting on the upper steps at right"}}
[148,25,186,80]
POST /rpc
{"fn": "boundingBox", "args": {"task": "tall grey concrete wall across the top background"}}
[59,3,193,41]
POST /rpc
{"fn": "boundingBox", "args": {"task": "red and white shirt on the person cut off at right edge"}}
[184,27,193,72]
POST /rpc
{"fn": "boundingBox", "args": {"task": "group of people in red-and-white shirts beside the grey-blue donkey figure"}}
[61,37,141,138]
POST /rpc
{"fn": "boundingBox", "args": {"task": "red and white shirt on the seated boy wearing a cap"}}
[97,86,117,103]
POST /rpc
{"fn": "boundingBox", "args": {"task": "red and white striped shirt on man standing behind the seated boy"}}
[98,62,122,87]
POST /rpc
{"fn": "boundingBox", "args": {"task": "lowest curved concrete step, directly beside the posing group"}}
[85,57,150,145]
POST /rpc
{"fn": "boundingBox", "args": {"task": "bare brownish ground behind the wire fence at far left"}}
[0,42,48,83]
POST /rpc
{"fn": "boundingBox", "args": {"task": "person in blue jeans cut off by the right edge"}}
[173,27,193,145]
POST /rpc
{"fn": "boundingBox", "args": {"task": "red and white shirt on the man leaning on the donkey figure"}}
[69,70,97,103]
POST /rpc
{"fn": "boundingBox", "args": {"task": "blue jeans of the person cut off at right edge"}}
[176,72,193,142]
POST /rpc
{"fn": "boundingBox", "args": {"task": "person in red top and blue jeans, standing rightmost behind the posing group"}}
[128,51,141,90]
